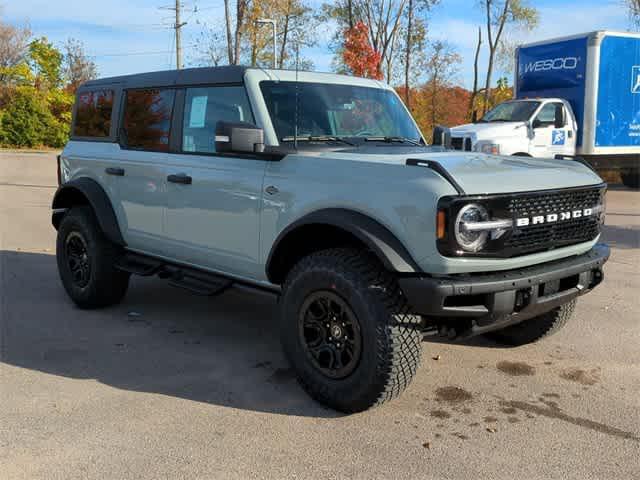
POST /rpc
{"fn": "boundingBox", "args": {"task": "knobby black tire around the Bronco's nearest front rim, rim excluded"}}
[280,248,422,413]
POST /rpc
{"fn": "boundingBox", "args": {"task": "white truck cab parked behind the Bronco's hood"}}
[451,98,577,158]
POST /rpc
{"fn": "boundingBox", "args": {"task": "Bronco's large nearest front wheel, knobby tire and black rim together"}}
[281,249,422,413]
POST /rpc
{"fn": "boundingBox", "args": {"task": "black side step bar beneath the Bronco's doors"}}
[116,252,278,296]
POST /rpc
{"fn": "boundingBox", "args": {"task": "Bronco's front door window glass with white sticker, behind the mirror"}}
[182,86,254,153]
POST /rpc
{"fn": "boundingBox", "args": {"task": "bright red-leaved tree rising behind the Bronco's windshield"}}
[342,22,382,80]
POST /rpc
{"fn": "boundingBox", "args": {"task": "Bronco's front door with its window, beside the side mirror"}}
[165,85,266,278]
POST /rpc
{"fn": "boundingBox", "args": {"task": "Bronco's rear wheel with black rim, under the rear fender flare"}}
[56,206,130,308]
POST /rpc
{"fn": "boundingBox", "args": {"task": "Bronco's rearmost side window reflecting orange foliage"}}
[73,90,113,137]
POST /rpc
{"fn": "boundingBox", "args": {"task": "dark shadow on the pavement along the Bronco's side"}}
[0,251,340,418]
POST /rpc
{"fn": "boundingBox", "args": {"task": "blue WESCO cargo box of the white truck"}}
[514,31,640,183]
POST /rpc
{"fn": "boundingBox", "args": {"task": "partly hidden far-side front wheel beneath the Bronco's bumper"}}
[486,300,577,347]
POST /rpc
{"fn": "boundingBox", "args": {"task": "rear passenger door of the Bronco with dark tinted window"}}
[110,89,175,255]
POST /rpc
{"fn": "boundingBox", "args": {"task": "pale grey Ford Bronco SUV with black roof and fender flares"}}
[52,67,609,412]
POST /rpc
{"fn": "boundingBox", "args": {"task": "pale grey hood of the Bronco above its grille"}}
[312,146,602,195]
